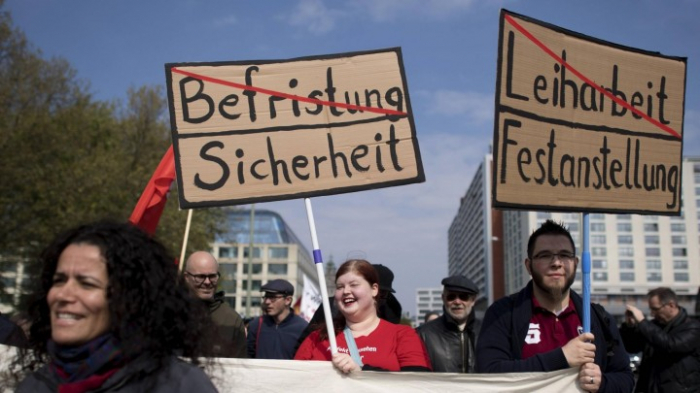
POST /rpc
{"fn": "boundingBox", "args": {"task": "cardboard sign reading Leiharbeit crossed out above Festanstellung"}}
[493,10,686,215]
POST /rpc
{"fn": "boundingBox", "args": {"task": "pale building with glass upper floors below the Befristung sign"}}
[211,209,318,317]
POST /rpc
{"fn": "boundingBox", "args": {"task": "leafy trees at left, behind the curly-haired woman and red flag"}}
[0,2,223,310]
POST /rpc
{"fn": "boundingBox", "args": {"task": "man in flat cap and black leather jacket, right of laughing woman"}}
[417,275,479,373]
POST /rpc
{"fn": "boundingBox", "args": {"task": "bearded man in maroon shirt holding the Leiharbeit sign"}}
[476,220,634,392]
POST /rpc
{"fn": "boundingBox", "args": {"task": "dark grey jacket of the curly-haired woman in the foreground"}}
[16,356,217,393]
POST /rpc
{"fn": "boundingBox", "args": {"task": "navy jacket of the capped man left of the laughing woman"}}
[248,309,308,359]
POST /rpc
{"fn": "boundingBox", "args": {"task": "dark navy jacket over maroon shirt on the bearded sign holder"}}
[476,281,634,393]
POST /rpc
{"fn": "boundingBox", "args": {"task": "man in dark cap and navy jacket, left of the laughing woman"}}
[248,279,307,359]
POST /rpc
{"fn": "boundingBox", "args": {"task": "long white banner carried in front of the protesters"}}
[0,345,584,393]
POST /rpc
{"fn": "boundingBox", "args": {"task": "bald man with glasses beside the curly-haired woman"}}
[184,251,247,358]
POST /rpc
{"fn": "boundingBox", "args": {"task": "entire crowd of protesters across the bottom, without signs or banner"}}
[0,221,700,393]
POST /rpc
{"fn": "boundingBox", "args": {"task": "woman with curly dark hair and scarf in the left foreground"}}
[10,222,216,393]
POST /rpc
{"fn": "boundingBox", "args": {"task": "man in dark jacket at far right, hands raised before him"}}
[620,287,700,392]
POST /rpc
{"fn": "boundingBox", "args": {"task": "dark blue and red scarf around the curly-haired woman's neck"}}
[46,333,124,383]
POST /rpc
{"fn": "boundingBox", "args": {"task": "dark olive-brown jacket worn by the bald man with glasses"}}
[205,291,248,358]
